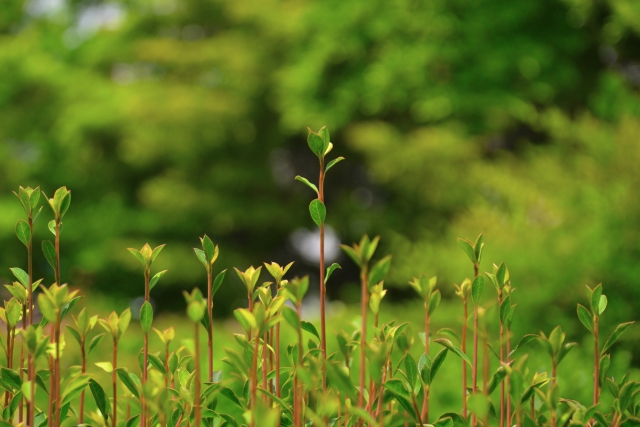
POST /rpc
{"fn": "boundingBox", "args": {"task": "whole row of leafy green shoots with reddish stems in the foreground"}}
[0,128,640,427]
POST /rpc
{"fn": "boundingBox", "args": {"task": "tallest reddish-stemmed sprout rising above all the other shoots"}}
[296,126,344,391]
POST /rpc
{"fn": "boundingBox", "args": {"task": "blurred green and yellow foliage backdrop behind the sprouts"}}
[0,0,640,383]
